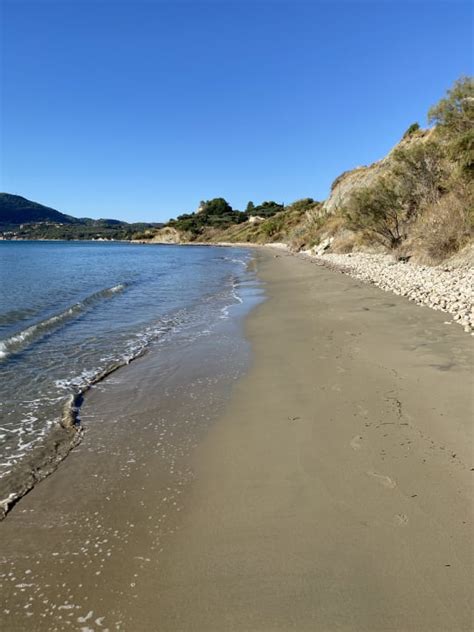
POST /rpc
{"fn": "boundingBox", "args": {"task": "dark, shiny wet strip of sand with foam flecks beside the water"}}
[0,253,261,632]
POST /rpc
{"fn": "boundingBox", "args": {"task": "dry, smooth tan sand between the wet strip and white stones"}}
[142,249,473,632]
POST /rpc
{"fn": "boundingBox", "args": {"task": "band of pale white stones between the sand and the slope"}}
[298,253,474,335]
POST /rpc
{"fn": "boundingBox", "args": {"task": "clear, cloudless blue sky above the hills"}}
[0,0,472,221]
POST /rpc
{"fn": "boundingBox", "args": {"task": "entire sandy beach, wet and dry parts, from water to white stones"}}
[0,250,474,632]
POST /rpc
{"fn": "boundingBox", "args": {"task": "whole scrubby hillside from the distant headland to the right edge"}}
[140,77,474,264]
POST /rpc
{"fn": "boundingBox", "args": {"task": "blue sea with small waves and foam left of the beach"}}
[0,242,258,492]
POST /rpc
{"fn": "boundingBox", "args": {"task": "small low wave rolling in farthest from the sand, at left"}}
[0,283,126,361]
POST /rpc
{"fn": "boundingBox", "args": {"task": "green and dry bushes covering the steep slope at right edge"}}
[342,78,474,261]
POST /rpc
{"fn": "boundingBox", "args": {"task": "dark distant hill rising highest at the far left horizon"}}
[0,193,79,226]
